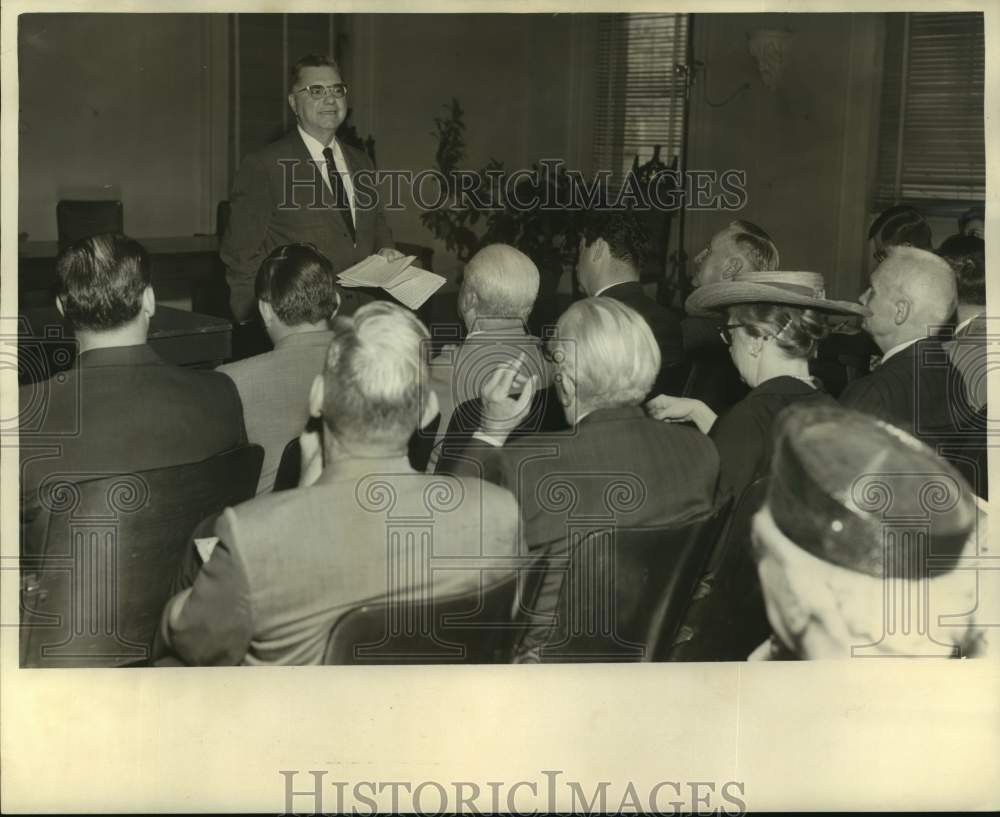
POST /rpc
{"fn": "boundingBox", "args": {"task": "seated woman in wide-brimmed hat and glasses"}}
[646,271,866,499]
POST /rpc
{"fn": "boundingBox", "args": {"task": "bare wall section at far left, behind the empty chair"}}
[19,14,229,240]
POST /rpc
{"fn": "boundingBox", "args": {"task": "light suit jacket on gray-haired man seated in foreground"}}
[161,456,518,665]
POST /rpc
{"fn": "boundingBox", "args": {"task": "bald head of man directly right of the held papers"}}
[458,244,539,330]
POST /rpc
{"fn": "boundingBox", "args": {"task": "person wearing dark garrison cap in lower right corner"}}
[751,406,993,659]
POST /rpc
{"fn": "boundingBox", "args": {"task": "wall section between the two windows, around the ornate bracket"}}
[687,14,883,299]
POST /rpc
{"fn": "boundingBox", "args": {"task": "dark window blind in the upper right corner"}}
[874,12,986,209]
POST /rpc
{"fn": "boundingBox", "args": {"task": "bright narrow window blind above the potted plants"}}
[594,14,688,187]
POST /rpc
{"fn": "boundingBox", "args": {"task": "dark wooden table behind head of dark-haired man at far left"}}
[18,306,232,384]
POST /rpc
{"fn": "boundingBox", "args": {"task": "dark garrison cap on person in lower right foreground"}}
[768,404,976,578]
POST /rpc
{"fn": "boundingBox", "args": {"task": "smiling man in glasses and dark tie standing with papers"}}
[220,55,401,321]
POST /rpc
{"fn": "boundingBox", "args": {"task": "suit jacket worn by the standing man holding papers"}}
[219,130,393,320]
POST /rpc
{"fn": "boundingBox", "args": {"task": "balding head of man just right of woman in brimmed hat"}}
[861,246,958,352]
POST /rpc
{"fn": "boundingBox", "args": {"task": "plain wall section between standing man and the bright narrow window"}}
[345,14,589,286]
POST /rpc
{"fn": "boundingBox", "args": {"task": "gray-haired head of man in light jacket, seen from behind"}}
[323,301,429,443]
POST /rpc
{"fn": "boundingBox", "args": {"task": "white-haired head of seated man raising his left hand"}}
[549,296,660,412]
